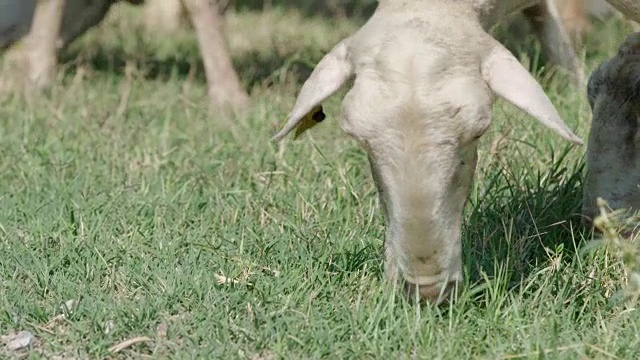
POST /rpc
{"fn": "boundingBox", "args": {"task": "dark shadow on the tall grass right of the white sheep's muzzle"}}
[463,147,589,289]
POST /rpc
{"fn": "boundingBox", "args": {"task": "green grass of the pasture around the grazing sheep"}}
[0,4,640,359]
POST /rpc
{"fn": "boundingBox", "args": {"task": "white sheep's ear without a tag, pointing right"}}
[482,44,583,145]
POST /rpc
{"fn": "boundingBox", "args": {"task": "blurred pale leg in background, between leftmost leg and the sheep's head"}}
[182,0,249,109]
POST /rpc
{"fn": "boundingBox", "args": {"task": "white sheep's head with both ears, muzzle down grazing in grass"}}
[274,0,581,303]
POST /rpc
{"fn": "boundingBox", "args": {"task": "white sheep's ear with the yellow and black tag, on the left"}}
[271,39,353,141]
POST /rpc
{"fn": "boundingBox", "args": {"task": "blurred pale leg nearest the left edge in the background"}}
[23,0,65,89]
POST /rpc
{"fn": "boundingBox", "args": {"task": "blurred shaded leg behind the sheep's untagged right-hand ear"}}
[524,0,585,86]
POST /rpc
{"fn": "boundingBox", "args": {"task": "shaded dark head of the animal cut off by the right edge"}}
[582,33,640,221]
